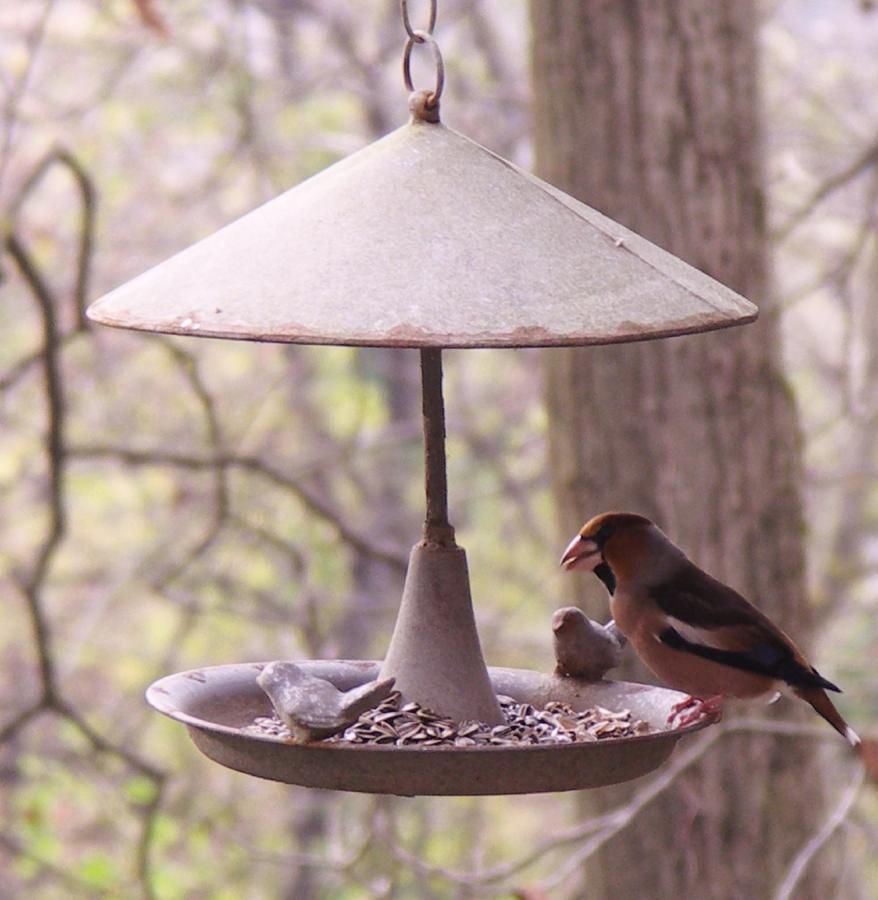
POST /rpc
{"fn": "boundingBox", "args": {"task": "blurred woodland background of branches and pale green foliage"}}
[0,0,878,900]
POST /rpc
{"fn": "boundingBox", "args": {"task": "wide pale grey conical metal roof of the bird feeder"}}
[89,121,757,347]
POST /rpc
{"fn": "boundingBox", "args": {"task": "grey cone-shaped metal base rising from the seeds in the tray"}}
[380,544,504,724]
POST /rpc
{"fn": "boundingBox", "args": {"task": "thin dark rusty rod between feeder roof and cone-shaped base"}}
[421,347,457,549]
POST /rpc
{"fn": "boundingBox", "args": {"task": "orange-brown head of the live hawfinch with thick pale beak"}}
[561,512,685,593]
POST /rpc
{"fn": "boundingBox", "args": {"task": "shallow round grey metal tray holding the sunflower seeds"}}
[146,660,707,796]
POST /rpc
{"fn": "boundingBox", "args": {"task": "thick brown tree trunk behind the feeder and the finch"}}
[531,0,836,900]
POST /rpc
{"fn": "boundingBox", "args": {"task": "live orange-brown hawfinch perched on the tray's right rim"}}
[561,512,860,746]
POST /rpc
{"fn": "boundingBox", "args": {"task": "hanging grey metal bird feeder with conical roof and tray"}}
[88,2,757,794]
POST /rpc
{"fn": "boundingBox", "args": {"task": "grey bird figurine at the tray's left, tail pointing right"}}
[256,662,394,744]
